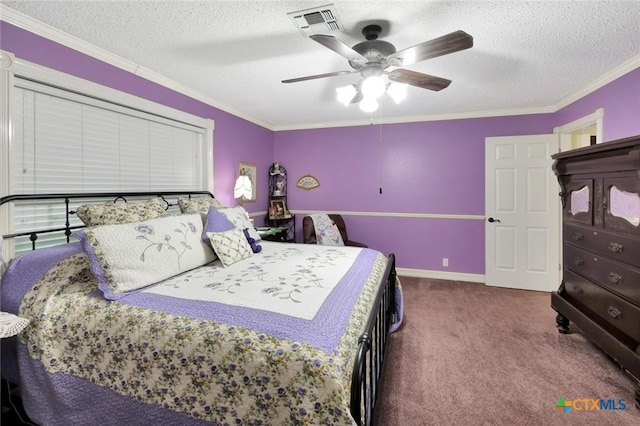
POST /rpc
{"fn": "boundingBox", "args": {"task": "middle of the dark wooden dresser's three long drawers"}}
[563,244,640,302]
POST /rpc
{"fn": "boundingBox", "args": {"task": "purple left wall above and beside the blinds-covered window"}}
[0,22,273,212]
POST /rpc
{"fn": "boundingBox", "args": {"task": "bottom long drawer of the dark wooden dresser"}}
[564,270,640,342]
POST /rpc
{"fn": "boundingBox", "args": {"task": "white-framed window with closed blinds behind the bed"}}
[0,56,213,255]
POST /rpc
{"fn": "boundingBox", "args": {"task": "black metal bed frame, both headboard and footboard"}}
[0,191,396,425]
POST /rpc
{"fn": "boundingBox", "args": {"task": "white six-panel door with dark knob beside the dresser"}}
[485,135,562,291]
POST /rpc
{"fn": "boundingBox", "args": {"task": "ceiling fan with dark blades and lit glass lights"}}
[282,24,473,111]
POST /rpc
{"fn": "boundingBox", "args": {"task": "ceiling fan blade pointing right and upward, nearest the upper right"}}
[387,31,473,66]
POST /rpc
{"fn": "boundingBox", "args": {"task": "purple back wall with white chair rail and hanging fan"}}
[274,115,552,274]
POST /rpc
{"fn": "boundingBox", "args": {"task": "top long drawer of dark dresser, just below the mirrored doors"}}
[564,224,640,267]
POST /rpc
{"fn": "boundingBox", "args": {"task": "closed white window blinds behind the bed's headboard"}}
[10,79,205,252]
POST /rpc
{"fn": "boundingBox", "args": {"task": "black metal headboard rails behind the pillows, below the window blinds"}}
[0,191,215,250]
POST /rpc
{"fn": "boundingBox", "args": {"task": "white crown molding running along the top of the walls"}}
[0,3,640,132]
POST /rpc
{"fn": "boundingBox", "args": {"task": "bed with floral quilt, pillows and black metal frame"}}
[0,192,402,425]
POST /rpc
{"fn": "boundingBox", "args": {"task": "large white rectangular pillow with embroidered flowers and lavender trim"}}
[76,213,216,300]
